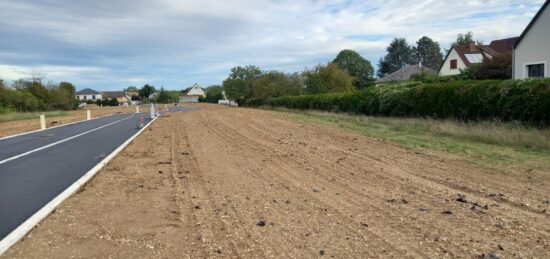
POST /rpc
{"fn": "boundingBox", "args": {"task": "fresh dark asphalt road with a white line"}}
[0,113,155,240]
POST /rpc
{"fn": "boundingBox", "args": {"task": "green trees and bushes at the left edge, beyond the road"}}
[0,77,78,113]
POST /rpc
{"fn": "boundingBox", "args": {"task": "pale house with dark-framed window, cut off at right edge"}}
[512,0,550,79]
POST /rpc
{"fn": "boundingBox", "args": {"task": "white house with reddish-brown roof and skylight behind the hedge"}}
[439,37,518,76]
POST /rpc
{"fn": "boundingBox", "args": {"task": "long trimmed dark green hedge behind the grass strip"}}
[244,79,550,126]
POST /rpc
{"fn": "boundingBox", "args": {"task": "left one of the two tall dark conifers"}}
[377,38,414,77]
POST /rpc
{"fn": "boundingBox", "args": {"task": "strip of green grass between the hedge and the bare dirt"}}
[277,109,550,172]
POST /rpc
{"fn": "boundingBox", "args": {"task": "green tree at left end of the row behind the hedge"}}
[222,66,262,103]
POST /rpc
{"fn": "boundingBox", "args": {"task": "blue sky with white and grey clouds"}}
[0,0,544,90]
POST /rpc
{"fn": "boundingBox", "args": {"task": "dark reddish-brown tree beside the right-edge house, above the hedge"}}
[475,53,512,80]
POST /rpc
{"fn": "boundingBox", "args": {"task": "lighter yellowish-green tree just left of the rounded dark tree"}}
[304,63,354,94]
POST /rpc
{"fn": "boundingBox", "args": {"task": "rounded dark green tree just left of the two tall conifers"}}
[332,49,374,89]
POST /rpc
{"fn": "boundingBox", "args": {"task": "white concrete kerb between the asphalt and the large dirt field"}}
[0,116,159,255]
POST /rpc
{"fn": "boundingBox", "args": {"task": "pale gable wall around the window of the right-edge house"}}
[513,4,550,79]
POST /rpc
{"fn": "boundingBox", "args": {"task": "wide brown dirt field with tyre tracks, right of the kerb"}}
[3,106,550,258]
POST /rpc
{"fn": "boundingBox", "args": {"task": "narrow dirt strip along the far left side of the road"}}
[0,107,142,138]
